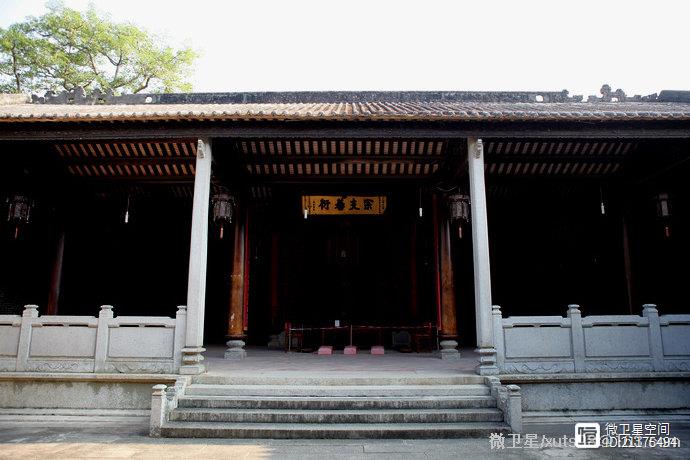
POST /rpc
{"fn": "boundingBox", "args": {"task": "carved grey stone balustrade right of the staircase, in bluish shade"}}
[492,304,690,374]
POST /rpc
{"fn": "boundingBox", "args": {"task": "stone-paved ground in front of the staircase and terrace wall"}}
[0,418,690,460]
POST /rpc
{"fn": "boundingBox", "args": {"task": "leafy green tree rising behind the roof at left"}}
[0,3,196,94]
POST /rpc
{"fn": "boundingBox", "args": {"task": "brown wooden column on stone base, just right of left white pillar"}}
[225,209,247,359]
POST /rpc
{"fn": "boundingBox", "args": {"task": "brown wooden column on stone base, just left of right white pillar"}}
[439,218,460,359]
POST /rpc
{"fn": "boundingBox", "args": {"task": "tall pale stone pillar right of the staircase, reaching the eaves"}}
[467,138,498,375]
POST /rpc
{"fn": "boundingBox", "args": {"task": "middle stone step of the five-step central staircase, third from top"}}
[178,395,496,410]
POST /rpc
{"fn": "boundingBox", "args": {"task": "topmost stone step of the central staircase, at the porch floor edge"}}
[192,373,485,386]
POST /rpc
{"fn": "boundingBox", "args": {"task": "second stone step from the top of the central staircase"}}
[186,384,490,397]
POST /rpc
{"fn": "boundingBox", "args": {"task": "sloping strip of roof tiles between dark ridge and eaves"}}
[0,101,690,122]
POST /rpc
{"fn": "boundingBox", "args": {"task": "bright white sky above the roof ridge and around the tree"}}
[0,0,690,96]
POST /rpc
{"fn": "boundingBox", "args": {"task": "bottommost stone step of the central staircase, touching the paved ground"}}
[161,421,510,439]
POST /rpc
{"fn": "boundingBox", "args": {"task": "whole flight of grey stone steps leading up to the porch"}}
[160,375,510,439]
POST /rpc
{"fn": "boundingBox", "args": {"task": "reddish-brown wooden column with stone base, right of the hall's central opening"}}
[434,195,460,359]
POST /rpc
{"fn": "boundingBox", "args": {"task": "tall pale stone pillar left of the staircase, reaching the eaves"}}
[180,139,213,374]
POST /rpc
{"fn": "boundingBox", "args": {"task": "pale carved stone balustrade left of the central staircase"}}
[0,305,187,374]
